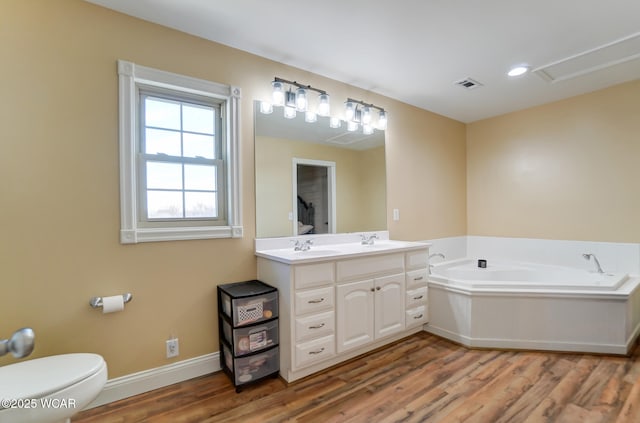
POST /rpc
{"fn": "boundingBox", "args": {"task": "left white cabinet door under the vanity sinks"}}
[336,279,376,353]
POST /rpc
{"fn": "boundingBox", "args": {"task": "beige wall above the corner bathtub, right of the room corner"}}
[467,80,640,242]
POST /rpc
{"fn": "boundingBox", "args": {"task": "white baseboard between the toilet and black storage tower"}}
[86,352,221,409]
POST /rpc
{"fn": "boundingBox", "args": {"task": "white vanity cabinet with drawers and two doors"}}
[257,244,428,382]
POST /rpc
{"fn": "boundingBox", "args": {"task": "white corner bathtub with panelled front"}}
[425,259,640,354]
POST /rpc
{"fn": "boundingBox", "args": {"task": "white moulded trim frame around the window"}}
[118,60,243,244]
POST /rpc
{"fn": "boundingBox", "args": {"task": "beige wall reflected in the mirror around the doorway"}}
[255,137,387,238]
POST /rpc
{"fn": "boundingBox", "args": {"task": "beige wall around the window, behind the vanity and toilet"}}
[0,0,466,378]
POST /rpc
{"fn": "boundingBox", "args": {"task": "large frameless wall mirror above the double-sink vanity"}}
[254,102,387,238]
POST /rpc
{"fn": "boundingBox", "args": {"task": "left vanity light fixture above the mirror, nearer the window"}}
[260,76,330,122]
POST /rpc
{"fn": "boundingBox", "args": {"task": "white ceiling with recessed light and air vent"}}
[87,0,640,123]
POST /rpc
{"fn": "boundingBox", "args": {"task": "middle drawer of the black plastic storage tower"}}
[222,319,278,356]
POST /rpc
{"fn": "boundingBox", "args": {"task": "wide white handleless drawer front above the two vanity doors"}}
[336,253,404,281]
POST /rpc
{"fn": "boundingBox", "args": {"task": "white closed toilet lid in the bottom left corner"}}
[0,353,106,399]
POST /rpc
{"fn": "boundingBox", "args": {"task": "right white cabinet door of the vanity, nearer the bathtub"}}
[374,273,405,339]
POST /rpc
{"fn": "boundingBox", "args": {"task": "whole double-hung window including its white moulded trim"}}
[118,61,242,244]
